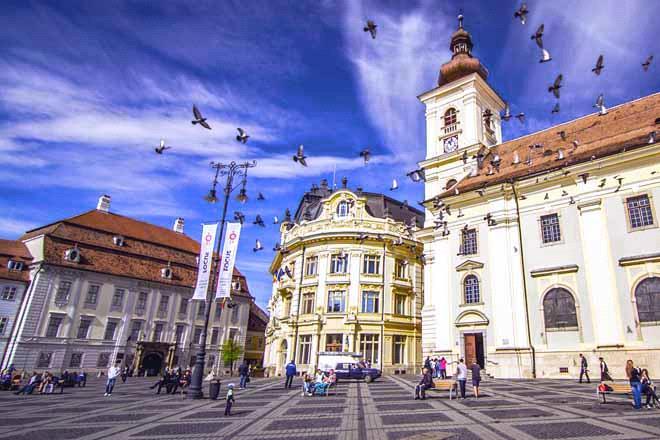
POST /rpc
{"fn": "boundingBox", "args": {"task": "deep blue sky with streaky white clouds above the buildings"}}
[0,0,660,306]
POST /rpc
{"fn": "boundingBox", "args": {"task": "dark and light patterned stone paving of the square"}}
[0,376,660,440]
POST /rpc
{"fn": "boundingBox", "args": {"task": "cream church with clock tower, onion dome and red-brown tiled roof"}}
[416,17,660,378]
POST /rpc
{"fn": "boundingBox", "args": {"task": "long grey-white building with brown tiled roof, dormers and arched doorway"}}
[0,196,264,375]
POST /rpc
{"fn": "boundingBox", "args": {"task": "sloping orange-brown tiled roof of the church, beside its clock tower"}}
[440,93,660,197]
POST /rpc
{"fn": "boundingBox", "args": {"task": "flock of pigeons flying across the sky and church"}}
[154,2,655,254]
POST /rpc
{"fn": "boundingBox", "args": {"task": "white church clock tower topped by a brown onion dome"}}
[418,15,505,217]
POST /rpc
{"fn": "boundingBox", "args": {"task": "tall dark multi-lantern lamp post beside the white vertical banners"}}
[188,161,257,399]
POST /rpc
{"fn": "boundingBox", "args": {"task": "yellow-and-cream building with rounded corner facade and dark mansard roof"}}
[264,179,422,375]
